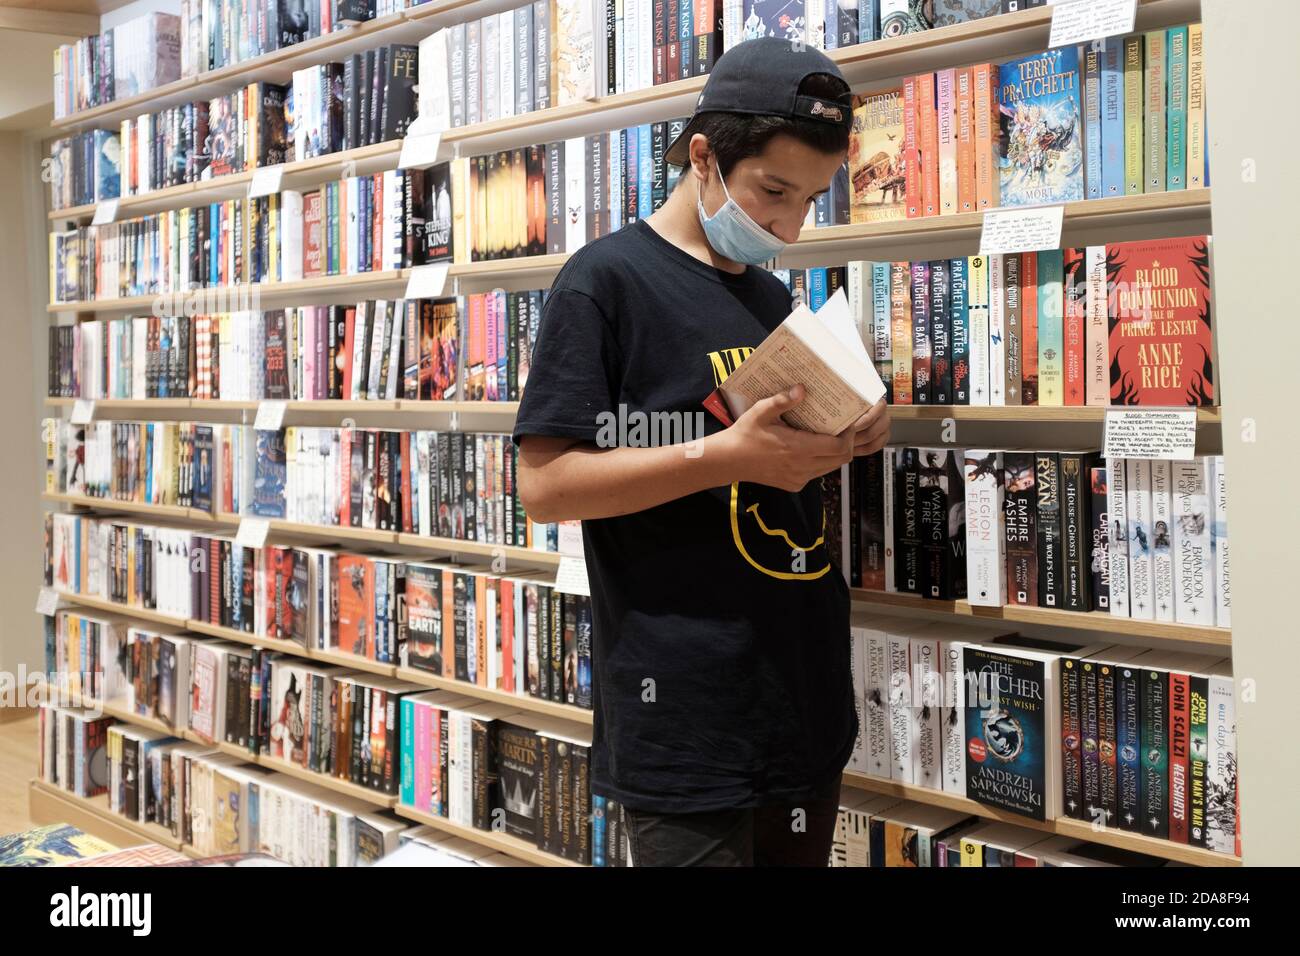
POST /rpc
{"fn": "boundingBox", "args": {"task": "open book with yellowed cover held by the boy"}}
[705,289,885,434]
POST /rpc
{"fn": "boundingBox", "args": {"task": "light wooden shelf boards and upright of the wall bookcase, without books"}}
[30,0,1295,866]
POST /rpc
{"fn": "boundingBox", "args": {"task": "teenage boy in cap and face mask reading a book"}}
[514,38,889,866]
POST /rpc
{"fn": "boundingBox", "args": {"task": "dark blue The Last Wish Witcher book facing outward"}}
[962,645,1060,821]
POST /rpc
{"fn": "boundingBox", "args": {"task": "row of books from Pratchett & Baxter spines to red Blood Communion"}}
[775,235,1218,407]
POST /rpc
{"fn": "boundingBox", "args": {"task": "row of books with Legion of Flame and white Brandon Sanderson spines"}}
[837,446,1232,627]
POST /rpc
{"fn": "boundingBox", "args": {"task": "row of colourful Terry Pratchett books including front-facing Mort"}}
[849,23,1209,222]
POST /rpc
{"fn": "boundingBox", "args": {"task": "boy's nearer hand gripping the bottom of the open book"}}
[719,385,863,492]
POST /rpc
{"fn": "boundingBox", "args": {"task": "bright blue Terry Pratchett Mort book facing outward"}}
[995,47,1083,206]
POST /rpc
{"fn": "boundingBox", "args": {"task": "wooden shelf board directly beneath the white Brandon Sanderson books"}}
[849,588,1232,653]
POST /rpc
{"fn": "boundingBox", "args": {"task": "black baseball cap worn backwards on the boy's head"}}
[664,36,853,166]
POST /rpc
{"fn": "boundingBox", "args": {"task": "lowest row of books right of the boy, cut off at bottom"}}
[831,791,1177,868]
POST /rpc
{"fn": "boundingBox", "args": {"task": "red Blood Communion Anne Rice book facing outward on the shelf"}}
[1106,235,1214,406]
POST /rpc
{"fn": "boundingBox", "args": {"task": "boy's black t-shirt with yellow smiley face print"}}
[514,221,858,813]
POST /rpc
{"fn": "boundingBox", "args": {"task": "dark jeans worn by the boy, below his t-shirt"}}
[623,779,840,866]
